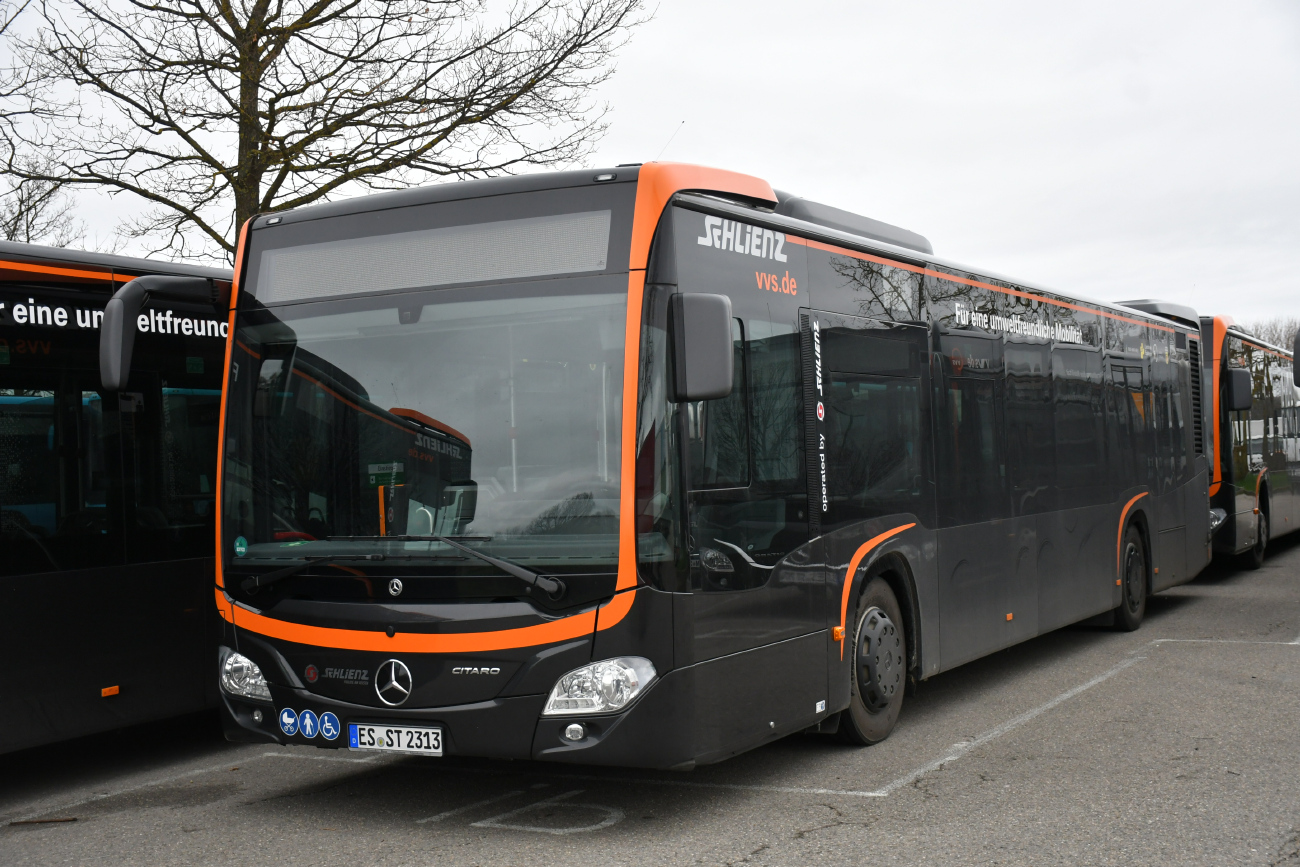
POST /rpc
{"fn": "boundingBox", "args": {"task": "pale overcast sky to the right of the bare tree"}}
[593,0,1300,320]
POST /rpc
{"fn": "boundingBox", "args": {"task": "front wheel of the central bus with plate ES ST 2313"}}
[839,577,907,745]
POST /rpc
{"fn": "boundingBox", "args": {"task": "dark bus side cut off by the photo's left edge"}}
[0,237,231,753]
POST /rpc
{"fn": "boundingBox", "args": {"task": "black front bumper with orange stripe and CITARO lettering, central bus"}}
[217,588,717,768]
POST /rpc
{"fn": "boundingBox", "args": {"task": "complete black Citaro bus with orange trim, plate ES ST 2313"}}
[200,162,1210,768]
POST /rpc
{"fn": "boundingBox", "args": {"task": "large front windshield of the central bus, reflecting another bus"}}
[224,284,627,576]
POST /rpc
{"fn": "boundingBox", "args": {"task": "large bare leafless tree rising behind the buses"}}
[0,0,644,257]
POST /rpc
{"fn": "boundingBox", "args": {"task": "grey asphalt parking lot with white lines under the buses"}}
[0,538,1300,867]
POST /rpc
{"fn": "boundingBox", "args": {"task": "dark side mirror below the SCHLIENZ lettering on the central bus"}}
[672,292,735,402]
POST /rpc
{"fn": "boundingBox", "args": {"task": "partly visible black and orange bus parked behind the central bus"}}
[1201,316,1300,568]
